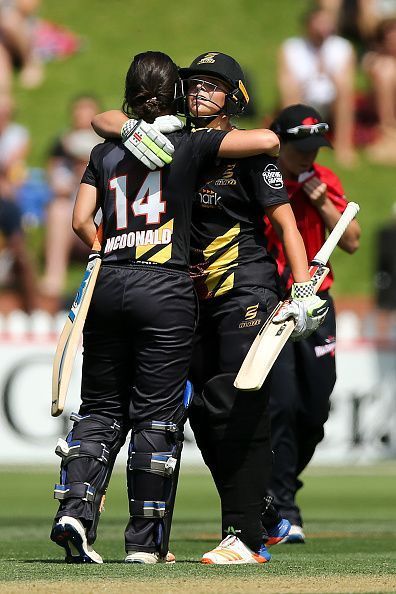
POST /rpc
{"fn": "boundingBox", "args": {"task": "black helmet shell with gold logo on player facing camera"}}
[179,52,245,87]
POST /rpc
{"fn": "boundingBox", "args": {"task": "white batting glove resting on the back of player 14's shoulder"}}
[121,119,175,170]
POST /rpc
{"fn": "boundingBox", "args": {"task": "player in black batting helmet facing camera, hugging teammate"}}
[95,52,327,564]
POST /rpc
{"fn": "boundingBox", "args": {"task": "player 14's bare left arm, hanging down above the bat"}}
[72,183,99,248]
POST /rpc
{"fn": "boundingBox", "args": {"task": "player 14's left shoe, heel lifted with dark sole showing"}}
[50,516,103,563]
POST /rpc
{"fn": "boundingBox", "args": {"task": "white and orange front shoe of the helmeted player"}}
[201,534,271,565]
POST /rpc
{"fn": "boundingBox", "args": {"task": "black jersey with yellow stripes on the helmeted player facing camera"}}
[190,155,289,299]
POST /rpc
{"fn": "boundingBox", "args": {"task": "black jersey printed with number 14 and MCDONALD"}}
[81,129,226,269]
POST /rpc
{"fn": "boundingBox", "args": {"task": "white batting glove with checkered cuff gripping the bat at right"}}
[273,281,329,340]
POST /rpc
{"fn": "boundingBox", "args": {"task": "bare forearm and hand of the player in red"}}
[303,176,360,254]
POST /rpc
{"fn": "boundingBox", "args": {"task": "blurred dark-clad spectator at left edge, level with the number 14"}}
[0,168,37,313]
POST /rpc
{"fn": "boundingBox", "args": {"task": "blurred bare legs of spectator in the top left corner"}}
[0,0,44,91]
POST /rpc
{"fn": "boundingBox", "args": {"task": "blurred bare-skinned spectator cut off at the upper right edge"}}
[363,18,396,164]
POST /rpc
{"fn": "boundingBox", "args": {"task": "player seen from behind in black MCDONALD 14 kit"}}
[51,52,284,564]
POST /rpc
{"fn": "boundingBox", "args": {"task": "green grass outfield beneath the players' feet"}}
[0,463,396,594]
